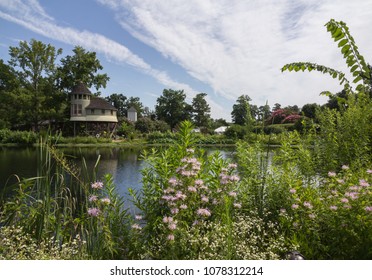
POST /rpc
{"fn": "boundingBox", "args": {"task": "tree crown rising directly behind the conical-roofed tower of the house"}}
[58,46,110,92]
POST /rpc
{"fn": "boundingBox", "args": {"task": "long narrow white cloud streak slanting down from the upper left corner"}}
[0,0,214,114]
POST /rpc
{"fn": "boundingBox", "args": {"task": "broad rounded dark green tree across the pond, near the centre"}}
[155,89,190,129]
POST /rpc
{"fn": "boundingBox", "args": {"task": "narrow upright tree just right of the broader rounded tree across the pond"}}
[192,93,211,127]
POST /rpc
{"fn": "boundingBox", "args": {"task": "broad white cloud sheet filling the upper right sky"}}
[98,0,372,105]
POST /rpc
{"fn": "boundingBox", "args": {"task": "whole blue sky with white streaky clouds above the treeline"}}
[0,0,372,121]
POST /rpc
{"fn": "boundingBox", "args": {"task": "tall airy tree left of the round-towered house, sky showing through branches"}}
[9,39,63,130]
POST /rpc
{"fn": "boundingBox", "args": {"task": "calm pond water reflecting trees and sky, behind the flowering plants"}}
[0,147,234,206]
